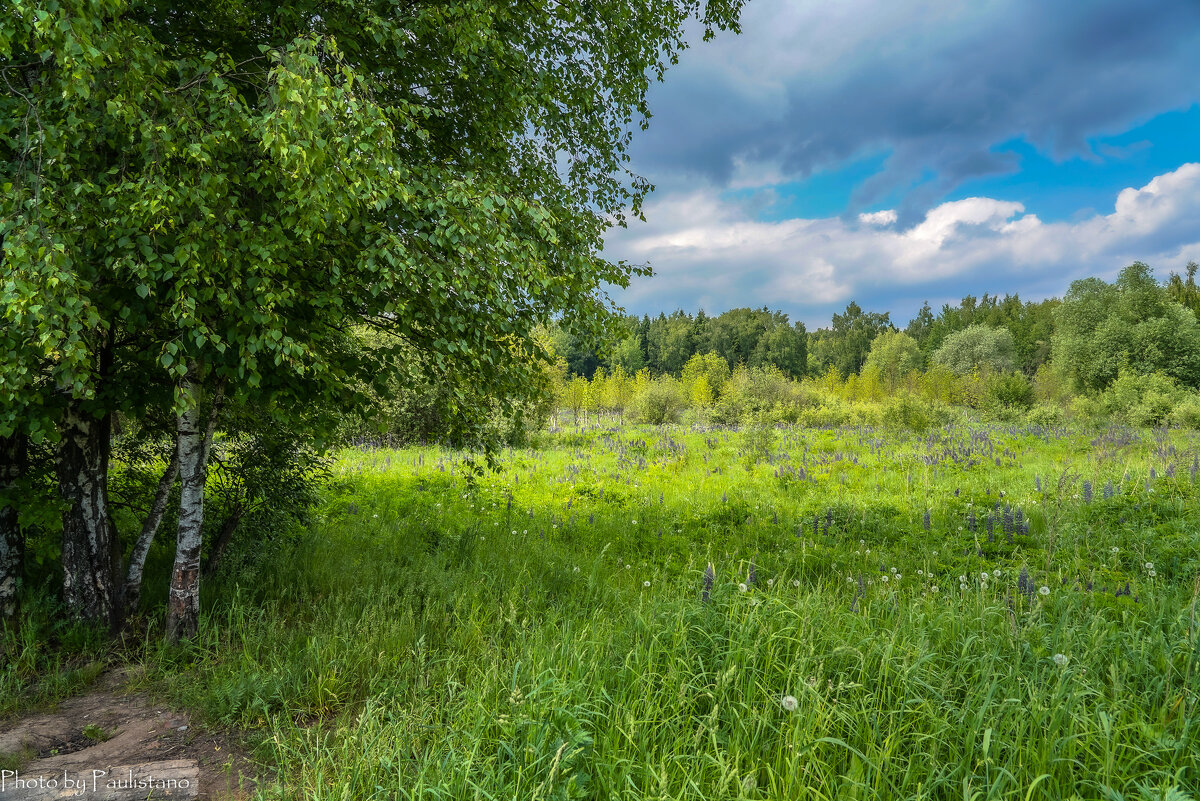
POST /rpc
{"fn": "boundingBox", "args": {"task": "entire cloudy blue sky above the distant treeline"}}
[605,0,1200,330]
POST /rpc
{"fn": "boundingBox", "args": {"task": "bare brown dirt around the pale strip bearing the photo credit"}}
[0,671,264,801]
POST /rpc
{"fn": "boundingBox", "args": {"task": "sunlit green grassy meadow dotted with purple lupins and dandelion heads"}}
[136,421,1200,801]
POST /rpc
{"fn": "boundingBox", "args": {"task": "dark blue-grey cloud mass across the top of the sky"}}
[634,0,1200,212]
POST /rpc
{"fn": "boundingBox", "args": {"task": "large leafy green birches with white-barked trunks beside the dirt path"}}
[0,0,742,633]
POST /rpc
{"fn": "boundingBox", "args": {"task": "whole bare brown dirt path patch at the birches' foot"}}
[0,671,263,801]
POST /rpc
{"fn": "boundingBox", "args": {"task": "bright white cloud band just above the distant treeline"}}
[606,163,1200,325]
